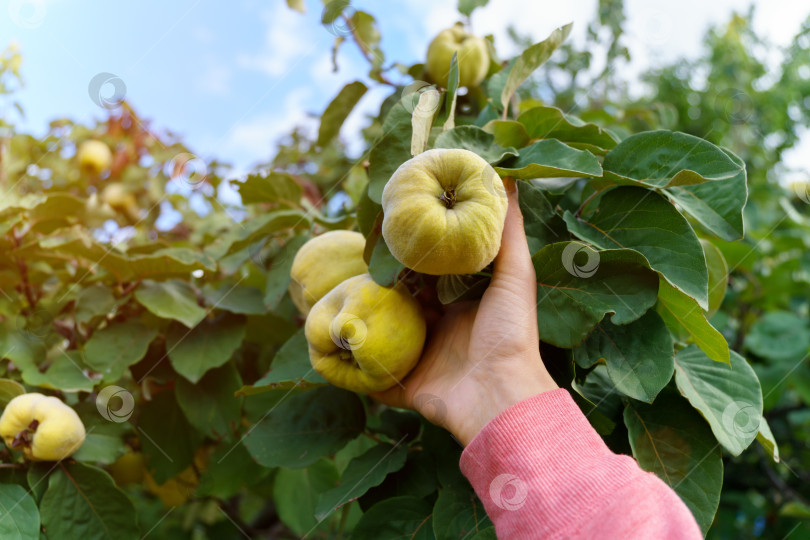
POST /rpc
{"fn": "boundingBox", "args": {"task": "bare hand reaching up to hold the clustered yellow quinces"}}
[372,178,557,446]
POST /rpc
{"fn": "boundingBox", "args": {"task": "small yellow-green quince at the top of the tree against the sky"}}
[425,24,489,88]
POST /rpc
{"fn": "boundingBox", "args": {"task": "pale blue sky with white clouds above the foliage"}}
[0,0,810,178]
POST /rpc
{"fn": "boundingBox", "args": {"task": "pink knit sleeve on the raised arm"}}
[461,389,703,540]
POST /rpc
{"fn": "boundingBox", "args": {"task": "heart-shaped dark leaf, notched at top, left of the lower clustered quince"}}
[166,314,245,383]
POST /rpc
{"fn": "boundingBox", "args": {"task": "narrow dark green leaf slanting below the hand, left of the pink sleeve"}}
[315,444,408,519]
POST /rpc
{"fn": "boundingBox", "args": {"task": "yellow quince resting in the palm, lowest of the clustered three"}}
[305,274,426,393]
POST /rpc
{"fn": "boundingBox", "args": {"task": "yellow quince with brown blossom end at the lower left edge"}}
[0,393,85,461]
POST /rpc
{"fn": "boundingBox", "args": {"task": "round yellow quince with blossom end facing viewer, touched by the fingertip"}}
[382,149,507,275]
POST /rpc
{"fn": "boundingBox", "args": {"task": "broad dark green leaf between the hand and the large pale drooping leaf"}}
[572,310,674,403]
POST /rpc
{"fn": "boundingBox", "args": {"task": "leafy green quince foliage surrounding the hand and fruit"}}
[0,0,810,539]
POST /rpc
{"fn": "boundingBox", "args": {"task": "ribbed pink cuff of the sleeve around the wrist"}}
[461,389,637,538]
